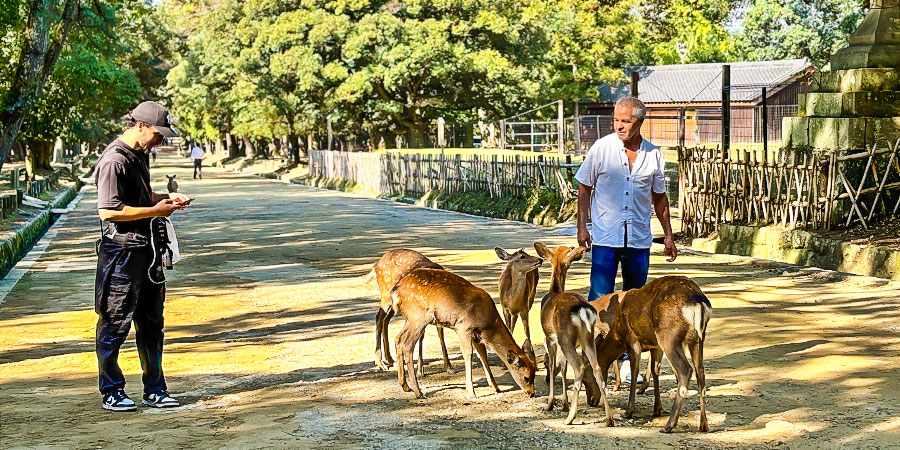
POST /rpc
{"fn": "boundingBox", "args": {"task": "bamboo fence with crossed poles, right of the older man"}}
[678,140,900,235]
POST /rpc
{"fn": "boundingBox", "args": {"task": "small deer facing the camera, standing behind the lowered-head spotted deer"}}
[494,247,544,341]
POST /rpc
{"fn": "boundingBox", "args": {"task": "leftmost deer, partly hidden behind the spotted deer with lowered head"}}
[366,249,453,376]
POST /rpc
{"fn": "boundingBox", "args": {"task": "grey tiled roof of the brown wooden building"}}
[598,59,812,103]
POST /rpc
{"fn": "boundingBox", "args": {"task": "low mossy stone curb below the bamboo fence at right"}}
[691,224,900,280]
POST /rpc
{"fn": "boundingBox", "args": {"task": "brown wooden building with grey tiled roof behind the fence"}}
[575,59,816,153]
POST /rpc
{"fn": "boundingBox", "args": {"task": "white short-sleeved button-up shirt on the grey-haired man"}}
[575,133,666,248]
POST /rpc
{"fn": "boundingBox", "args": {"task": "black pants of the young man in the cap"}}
[94,238,166,394]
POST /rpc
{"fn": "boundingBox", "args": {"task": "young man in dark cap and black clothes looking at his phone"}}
[94,101,191,411]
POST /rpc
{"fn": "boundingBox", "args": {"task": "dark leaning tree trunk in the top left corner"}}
[0,0,81,170]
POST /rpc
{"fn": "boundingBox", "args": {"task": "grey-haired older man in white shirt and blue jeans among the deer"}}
[575,97,678,378]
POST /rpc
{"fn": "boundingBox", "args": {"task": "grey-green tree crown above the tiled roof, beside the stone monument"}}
[737,0,869,65]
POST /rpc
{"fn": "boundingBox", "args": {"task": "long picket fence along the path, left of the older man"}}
[309,150,578,199]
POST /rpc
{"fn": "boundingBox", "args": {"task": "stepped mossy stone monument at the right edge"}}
[782,0,900,151]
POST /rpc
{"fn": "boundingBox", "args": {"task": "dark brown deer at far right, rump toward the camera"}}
[597,276,712,433]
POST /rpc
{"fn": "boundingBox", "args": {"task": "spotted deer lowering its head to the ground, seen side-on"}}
[391,269,535,398]
